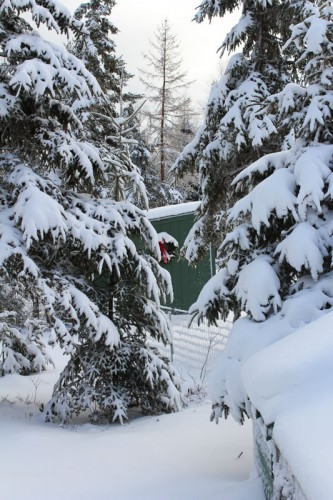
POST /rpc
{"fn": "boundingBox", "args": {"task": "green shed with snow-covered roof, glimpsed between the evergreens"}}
[148,201,215,311]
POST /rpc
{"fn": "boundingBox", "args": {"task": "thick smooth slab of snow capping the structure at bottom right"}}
[242,312,333,500]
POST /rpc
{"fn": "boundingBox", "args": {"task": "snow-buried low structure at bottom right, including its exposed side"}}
[210,312,333,500]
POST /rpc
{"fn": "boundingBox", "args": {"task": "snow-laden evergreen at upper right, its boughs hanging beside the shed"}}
[172,0,292,262]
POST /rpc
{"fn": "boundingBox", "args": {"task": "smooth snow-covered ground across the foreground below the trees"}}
[0,348,264,500]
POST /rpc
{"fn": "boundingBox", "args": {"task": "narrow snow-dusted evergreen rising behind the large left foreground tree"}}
[69,0,147,208]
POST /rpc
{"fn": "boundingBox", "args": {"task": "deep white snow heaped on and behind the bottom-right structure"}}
[209,306,333,500]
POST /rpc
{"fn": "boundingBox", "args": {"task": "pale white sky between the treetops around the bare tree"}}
[67,0,239,110]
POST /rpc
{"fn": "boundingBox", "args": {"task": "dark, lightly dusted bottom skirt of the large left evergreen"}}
[46,337,183,423]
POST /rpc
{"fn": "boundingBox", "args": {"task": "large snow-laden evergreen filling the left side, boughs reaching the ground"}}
[0,0,181,421]
